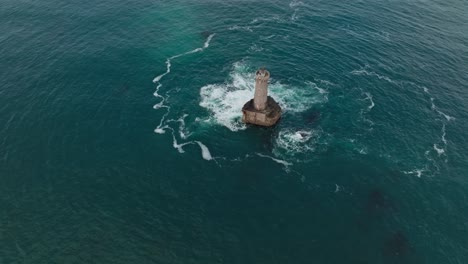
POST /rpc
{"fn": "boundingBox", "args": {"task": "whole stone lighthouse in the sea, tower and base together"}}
[242,68,281,126]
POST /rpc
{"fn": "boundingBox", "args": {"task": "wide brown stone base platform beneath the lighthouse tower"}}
[242,96,281,127]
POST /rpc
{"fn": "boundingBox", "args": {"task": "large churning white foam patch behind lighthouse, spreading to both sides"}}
[200,63,328,131]
